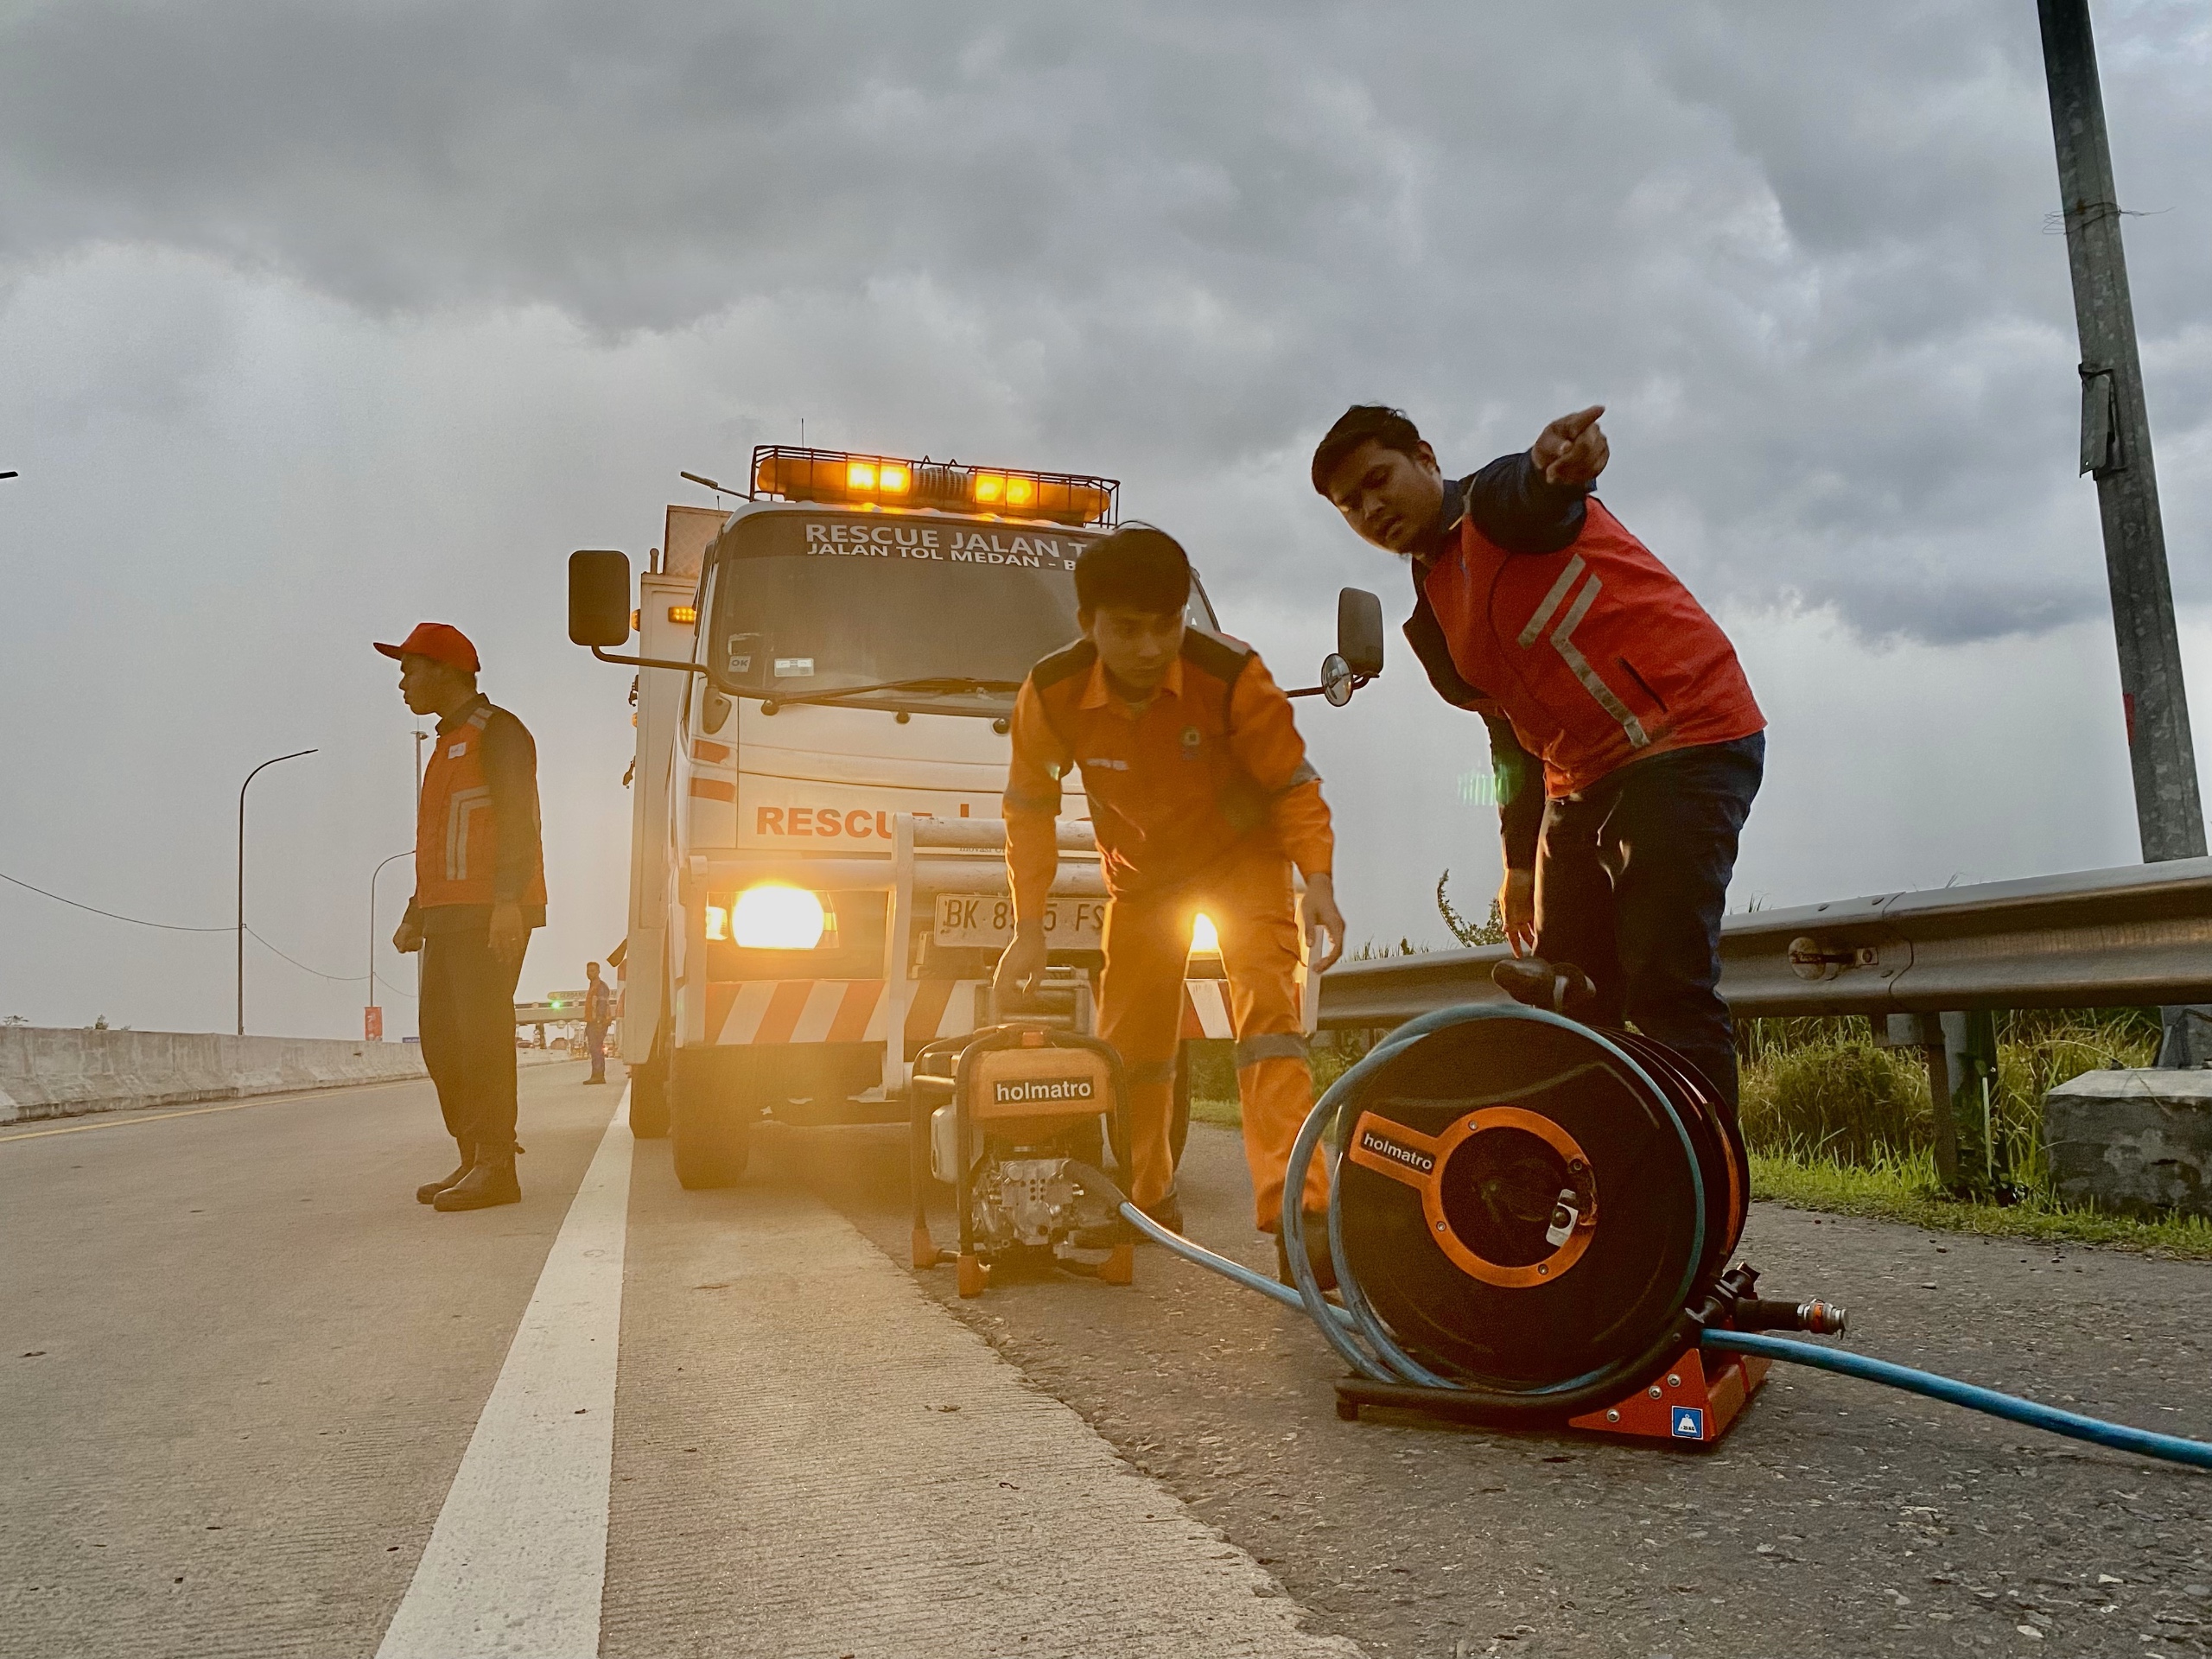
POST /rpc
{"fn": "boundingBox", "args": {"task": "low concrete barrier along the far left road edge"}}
[0,1027,569,1123]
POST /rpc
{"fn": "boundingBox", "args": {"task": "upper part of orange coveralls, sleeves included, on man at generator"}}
[1004,628,1336,916]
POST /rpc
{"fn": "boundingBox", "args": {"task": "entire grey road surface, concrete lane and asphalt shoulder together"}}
[0,1066,2212,1659]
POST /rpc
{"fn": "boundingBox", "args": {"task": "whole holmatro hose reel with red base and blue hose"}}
[1122,1004,2212,1469]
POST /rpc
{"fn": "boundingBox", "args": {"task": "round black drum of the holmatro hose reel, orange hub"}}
[1330,1008,1747,1394]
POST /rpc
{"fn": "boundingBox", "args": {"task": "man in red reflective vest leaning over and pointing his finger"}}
[1312,404,1765,1106]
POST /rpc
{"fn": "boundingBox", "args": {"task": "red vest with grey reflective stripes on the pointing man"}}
[1422,495,1767,798]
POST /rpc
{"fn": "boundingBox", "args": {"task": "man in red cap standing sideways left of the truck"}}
[376,621,546,1210]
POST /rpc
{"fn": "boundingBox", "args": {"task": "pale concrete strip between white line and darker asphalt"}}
[604,1144,1358,1659]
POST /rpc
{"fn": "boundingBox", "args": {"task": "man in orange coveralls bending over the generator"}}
[995,524,1344,1285]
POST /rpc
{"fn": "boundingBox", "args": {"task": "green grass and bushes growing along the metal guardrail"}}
[1190,872,2212,1261]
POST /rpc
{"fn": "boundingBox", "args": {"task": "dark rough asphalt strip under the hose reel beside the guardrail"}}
[785,1123,2212,1659]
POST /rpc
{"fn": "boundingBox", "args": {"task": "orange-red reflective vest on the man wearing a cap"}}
[414,696,546,909]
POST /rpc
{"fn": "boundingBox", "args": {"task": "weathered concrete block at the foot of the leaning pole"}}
[2044,1071,2212,1217]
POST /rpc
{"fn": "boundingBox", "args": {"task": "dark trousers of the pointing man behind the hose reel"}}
[1535,732,1767,1106]
